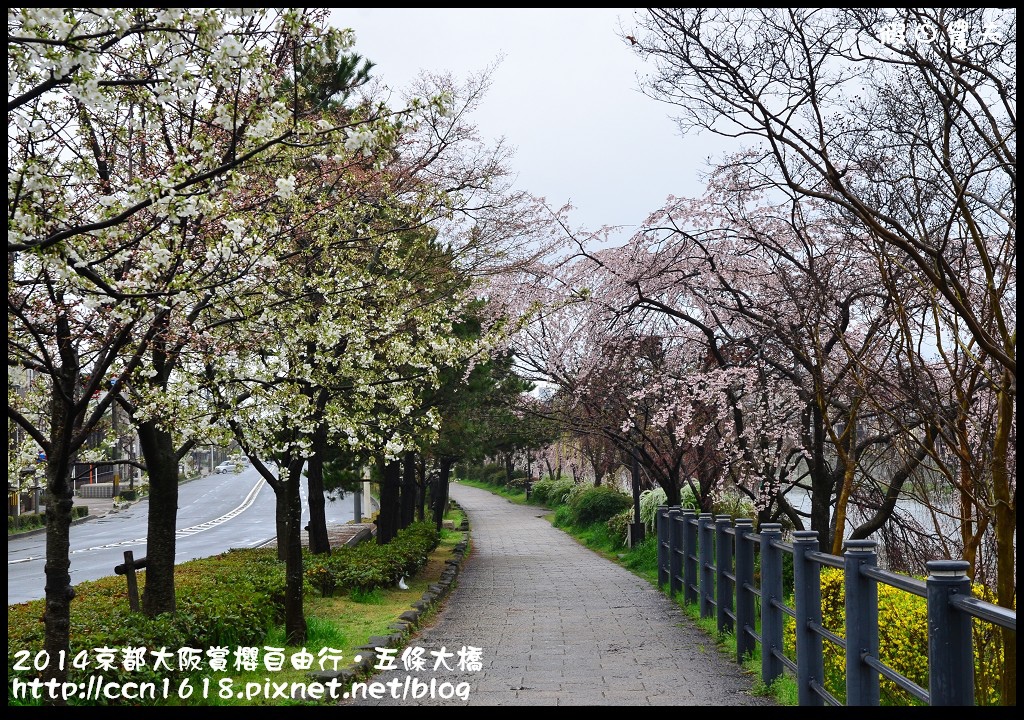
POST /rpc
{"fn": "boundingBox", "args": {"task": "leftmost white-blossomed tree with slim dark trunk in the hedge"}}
[8,8,368,679]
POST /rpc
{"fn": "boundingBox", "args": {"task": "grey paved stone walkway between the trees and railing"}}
[343,483,774,706]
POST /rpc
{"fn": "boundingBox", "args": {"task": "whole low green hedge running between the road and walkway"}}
[7,522,439,708]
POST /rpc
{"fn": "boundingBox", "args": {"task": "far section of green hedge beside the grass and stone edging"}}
[306,522,440,597]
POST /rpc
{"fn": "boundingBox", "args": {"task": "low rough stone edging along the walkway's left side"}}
[310,500,469,685]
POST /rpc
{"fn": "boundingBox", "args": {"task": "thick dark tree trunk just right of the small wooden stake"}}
[138,420,178,618]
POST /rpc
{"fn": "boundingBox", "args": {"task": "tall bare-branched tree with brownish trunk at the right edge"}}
[630,12,1017,702]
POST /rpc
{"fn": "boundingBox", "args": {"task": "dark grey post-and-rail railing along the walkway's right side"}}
[656,505,1017,706]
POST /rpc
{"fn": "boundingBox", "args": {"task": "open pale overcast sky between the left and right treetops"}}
[332,8,725,247]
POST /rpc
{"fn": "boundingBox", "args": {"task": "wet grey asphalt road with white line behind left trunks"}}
[7,468,353,605]
